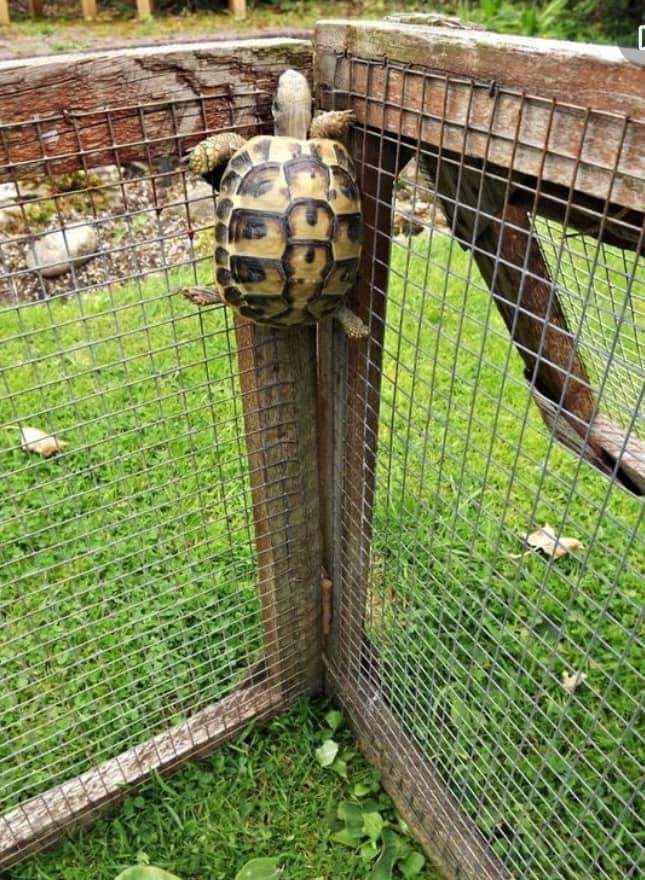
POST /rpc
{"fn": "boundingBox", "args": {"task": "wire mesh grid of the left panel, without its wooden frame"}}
[0,77,320,845]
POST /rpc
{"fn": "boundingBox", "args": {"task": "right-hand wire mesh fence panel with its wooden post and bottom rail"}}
[317,24,645,880]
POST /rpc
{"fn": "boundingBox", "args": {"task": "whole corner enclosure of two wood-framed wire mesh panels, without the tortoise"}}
[0,17,645,880]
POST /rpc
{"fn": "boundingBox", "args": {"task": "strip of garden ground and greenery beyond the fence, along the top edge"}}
[0,0,642,54]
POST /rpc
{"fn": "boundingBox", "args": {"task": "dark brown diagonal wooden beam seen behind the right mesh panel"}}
[426,155,645,495]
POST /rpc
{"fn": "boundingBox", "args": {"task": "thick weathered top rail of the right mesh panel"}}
[316,21,645,211]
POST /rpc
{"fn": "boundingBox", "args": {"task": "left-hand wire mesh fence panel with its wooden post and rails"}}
[0,44,319,864]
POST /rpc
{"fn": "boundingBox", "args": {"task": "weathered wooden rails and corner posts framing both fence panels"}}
[0,15,645,880]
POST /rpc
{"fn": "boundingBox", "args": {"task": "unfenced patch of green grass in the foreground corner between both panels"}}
[7,704,436,880]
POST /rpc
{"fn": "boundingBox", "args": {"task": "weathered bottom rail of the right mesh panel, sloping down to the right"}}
[327,665,512,880]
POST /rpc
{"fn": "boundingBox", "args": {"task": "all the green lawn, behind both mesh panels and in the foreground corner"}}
[0,222,643,880]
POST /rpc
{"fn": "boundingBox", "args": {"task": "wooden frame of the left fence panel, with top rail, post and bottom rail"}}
[0,31,314,871]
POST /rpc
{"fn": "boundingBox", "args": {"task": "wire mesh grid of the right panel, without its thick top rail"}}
[328,56,643,878]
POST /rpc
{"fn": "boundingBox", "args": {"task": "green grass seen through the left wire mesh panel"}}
[0,268,262,809]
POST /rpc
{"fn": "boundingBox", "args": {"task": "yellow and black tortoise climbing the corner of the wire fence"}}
[183,70,367,338]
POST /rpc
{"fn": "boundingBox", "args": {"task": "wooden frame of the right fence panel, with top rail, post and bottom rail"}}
[315,16,645,880]
